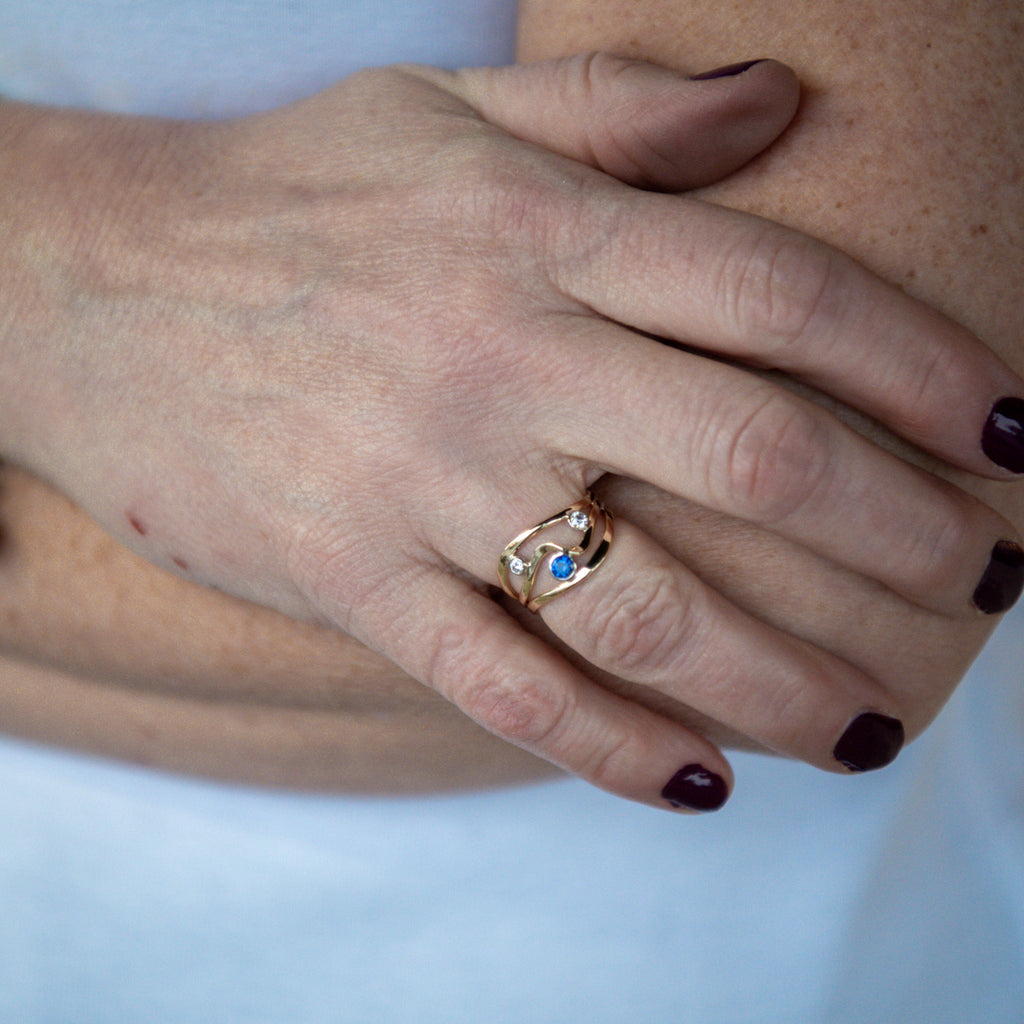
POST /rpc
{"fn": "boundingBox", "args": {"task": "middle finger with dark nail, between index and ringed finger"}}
[544,317,1024,615]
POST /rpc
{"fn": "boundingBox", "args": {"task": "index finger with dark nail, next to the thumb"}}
[558,193,1024,477]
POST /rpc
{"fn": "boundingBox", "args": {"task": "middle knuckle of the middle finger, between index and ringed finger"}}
[710,393,831,525]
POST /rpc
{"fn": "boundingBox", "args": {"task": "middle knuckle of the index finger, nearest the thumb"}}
[721,228,839,356]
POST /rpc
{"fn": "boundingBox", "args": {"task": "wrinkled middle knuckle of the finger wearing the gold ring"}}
[584,567,693,678]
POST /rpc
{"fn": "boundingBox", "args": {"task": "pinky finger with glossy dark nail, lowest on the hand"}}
[356,577,732,811]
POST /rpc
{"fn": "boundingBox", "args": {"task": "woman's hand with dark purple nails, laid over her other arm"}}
[3,58,1022,806]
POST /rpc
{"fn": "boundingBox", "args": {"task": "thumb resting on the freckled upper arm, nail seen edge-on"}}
[440,53,800,191]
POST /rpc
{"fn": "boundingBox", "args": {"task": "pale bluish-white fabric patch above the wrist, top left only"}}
[0,0,515,117]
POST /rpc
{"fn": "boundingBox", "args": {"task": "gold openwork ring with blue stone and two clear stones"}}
[498,495,612,611]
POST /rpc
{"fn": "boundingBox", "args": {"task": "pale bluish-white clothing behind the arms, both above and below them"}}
[0,0,1024,1024]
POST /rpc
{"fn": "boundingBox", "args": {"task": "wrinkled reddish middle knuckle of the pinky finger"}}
[429,624,569,746]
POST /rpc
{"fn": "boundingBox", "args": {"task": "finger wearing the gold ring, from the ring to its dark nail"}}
[446,503,902,771]
